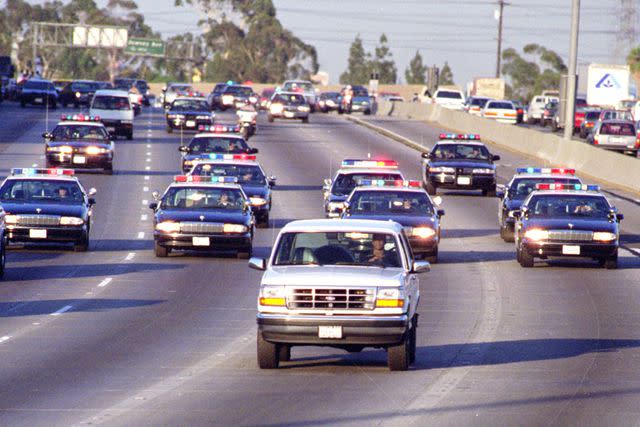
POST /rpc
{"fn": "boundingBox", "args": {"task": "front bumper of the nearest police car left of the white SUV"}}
[153,231,251,251]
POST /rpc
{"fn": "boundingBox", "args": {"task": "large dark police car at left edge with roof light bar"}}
[0,168,96,252]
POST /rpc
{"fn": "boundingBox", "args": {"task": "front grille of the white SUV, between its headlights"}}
[287,287,375,310]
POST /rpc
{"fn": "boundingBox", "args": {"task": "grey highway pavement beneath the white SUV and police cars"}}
[0,105,640,425]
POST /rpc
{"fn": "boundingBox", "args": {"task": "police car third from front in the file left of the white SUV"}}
[178,125,258,173]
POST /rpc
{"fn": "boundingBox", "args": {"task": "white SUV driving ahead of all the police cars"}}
[249,219,430,371]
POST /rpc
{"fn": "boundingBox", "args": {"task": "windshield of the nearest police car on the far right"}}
[528,194,611,219]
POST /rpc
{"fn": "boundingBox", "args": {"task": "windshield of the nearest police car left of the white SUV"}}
[160,186,245,210]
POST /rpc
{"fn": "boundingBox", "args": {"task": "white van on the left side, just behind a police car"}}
[89,90,133,139]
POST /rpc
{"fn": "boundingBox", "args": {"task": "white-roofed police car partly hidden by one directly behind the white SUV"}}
[322,159,404,218]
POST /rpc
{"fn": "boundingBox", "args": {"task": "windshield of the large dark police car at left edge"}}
[0,179,84,204]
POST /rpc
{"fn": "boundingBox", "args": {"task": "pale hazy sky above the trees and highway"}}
[26,0,640,85]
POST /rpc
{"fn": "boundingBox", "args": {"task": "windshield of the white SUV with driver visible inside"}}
[274,231,402,268]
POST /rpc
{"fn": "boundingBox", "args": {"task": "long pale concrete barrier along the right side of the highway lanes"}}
[378,102,640,193]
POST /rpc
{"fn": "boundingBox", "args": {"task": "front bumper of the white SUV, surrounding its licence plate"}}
[257,313,410,347]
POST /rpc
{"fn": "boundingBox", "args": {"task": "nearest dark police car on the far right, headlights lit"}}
[513,184,624,269]
